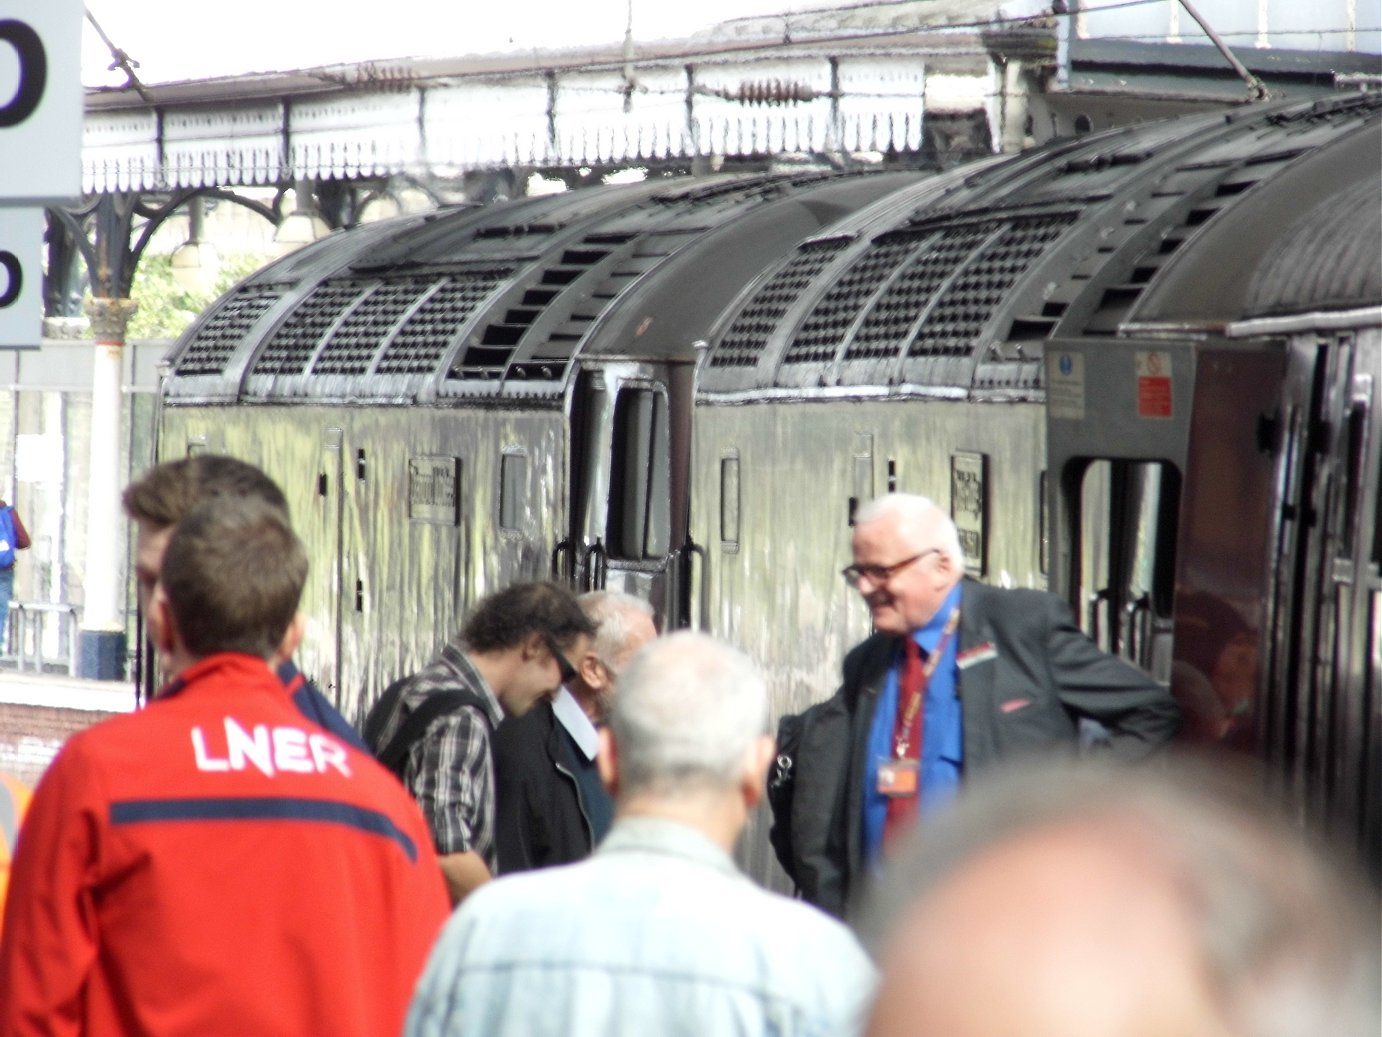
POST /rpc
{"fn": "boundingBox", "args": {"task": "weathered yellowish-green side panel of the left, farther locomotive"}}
[160,405,567,720]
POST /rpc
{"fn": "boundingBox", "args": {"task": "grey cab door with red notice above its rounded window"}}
[1046,342,1194,683]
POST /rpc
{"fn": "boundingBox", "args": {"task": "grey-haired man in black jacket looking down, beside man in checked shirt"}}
[495,590,658,874]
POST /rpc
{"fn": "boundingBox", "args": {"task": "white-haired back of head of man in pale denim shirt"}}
[609,630,768,796]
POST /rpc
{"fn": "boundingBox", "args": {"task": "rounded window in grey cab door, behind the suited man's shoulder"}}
[1077,460,1180,669]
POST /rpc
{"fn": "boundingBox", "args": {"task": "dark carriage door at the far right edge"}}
[1253,332,1382,877]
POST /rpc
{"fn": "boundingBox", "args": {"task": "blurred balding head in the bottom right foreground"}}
[862,758,1382,1037]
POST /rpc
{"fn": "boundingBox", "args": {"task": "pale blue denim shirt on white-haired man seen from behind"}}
[405,817,875,1037]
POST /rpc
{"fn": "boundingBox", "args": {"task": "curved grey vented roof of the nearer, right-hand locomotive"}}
[701,95,1382,397]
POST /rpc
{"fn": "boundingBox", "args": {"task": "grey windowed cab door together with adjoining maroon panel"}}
[1046,340,1285,748]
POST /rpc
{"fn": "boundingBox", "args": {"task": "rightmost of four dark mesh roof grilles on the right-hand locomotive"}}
[907,212,1079,357]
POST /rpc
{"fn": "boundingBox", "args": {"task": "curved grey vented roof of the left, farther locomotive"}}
[164,171,920,402]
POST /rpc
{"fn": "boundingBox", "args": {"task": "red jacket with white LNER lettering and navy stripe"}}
[0,654,449,1037]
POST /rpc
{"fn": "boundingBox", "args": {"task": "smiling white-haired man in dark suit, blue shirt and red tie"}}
[771,494,1179,915]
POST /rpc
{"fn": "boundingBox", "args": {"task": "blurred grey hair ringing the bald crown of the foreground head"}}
[861,759,1379,1037]
